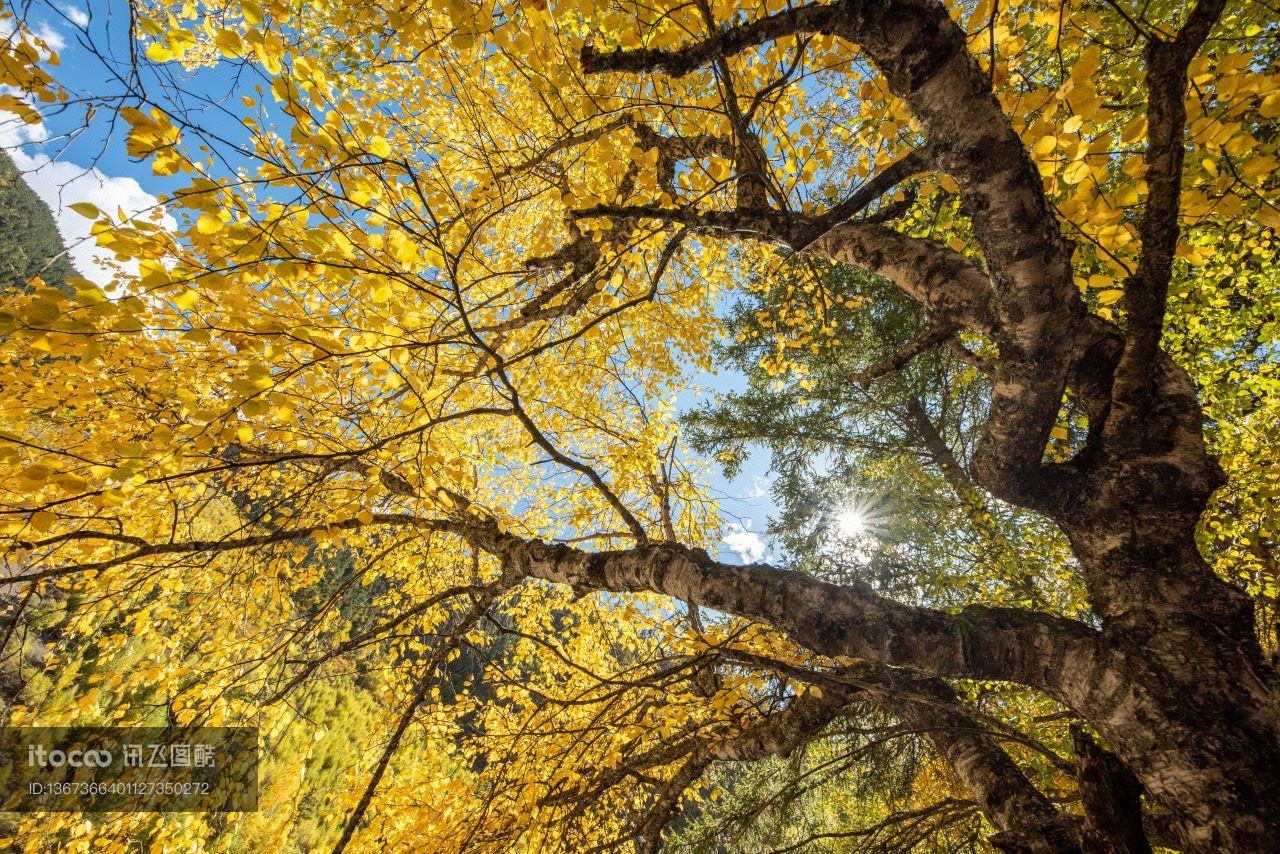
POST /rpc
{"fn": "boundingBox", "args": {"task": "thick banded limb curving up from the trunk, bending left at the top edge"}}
[582,0,1084,501]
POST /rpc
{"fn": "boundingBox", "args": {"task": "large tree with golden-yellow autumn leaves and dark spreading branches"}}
[0,0,1280,851]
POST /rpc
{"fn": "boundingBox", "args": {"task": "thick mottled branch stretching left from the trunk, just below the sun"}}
[463,522,1094,697]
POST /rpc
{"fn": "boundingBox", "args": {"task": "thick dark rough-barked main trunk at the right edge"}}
[1050,353,1280,851]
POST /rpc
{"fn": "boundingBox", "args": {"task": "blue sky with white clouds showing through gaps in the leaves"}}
[0,0,776,562]
